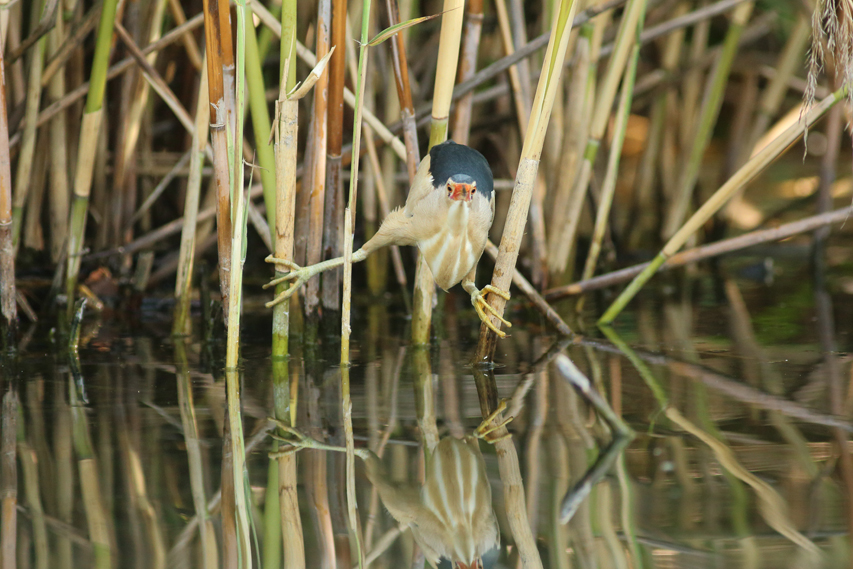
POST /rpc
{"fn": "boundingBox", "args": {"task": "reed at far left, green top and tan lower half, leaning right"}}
[65,0,118,319]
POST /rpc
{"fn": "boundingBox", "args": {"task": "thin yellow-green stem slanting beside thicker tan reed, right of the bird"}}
[582,15,645,280]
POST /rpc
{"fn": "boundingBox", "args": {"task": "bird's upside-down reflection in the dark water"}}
[271,403,512,569]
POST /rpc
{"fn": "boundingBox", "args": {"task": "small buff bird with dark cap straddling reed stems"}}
[264,140,512,338]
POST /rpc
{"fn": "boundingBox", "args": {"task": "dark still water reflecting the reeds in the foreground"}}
[3,254,853,568]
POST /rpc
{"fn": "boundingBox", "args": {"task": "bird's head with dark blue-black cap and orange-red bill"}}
[429,140,494,204]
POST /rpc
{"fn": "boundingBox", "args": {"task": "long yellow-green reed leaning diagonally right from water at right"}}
[598,87,847,324]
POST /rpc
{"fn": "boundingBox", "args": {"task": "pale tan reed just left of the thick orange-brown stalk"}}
[172,61,210,336]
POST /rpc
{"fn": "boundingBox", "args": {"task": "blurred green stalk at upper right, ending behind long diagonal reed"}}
[662,2,753,239]
